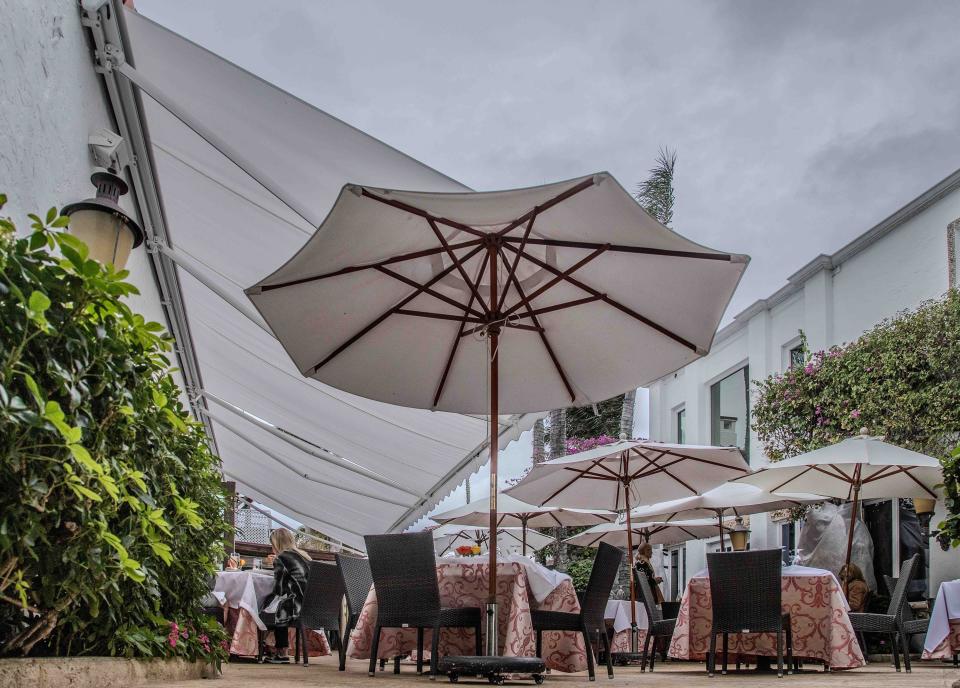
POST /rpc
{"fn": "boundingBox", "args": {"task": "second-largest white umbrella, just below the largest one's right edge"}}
[507,439,750,652]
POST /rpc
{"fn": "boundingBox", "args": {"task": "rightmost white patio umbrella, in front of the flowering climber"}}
[737,428,943,590]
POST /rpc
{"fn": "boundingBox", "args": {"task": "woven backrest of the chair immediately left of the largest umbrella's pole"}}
[363,532,440,628]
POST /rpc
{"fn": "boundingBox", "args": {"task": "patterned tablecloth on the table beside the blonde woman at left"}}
[213,571,330,657]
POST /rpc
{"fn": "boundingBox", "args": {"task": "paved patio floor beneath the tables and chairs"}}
[151,657,960,688]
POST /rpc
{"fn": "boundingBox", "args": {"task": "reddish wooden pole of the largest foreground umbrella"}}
[487,243,500,657]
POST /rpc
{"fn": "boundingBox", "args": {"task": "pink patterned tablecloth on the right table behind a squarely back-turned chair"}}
[669,567,864,669]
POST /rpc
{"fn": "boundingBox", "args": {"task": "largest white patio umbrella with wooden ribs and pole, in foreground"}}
[246,173,748,654]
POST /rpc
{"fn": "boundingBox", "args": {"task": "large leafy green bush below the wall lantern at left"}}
[0,197,226,659]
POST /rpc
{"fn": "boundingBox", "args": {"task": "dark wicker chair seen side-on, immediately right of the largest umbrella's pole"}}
[530,542,623,681]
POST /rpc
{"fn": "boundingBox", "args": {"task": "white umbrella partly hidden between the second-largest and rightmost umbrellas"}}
[631,482,823,549]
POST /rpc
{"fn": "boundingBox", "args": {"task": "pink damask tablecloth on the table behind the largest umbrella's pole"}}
[347,561,587,672]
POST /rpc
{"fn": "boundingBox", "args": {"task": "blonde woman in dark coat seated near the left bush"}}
[264,528,310,664]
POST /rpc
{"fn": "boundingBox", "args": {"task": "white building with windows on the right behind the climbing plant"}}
[650,170,960,596]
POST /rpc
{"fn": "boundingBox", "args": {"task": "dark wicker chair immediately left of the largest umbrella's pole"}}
[364,532,483,679]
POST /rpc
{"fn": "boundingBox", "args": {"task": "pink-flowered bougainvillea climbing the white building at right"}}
[751,290,960,546]
